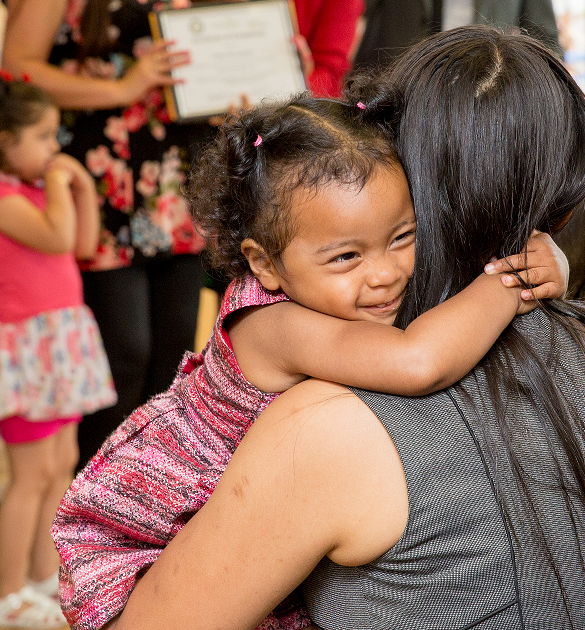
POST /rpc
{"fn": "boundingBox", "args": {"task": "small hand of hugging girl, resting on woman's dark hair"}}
[484,230,569,302]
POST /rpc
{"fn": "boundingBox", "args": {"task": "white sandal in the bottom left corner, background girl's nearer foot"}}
[0,585,67,630]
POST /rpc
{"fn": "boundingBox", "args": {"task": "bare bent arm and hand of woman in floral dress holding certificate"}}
[2,0,189,109]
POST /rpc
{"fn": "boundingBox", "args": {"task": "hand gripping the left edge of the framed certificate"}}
[119,40,190,103]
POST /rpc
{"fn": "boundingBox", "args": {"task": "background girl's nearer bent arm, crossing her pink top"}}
[0,167,77,254]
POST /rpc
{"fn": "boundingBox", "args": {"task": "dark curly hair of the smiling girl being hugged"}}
[186,94,398,280]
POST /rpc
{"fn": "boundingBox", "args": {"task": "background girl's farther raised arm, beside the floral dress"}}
[52,153,100,260]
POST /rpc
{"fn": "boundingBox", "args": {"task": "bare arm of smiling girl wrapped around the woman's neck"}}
[230,235,565,396]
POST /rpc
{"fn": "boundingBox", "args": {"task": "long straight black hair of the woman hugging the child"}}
[347,27,585,628]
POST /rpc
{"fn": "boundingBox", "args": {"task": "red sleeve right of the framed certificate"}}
[295,0,364,96]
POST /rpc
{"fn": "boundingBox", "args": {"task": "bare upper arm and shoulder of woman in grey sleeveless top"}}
[108,381,408,630]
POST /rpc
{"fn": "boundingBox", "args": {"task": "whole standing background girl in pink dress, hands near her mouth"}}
[0,75,116,628]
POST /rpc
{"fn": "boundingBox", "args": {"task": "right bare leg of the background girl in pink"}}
[29,422,79,582]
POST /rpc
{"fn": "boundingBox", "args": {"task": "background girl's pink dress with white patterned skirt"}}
[0,173,116,422]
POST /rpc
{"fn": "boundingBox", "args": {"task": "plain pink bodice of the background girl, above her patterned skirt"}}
[0,174,83,322]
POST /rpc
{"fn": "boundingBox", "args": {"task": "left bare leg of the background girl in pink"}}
[0,436,65,597]
